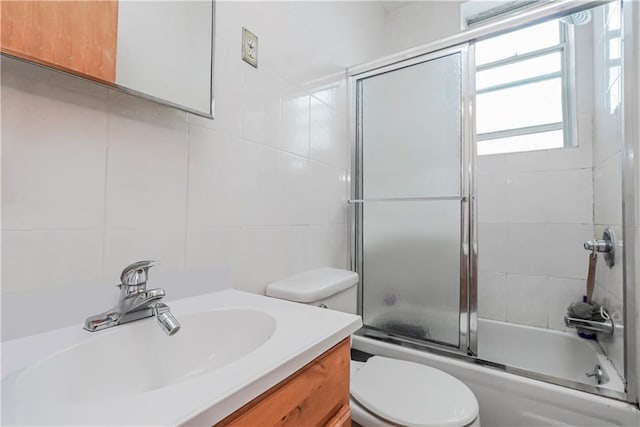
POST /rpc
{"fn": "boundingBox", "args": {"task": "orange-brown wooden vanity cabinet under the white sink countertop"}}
[218,338,351,427]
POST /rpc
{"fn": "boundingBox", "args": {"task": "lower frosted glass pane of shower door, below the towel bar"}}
[361,200,461,347]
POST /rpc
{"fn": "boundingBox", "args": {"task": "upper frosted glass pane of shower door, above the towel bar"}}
[360,52,462,199]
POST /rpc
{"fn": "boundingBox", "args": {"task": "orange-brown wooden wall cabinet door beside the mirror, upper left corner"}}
[0,0,118,83]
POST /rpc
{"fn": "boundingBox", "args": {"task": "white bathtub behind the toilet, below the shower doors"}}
[352,319,640,427]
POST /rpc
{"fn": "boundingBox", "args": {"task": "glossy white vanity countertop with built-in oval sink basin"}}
[0,289,362,426]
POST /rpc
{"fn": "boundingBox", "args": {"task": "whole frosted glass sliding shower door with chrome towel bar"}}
[352,46,470,353]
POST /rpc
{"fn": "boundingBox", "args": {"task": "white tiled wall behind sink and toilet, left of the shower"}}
[1,1,385,339]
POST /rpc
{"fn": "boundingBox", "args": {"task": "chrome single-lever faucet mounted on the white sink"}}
[84,261,180,335]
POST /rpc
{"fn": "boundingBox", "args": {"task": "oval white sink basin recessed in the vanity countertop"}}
[3,308,276,402]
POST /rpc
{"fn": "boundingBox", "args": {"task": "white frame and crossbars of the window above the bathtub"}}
[476,21,578,154]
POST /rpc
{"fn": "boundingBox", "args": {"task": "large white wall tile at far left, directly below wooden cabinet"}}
[2,74,107,230]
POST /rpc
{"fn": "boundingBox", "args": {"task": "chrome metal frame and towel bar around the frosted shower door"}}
[349,43,478,355]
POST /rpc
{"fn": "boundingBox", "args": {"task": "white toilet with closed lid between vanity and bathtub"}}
[266,267,480,427]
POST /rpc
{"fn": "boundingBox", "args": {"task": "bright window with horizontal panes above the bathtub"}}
[475,20,575,155]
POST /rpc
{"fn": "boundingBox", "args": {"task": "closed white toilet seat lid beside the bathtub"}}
[351,356,478,427]
